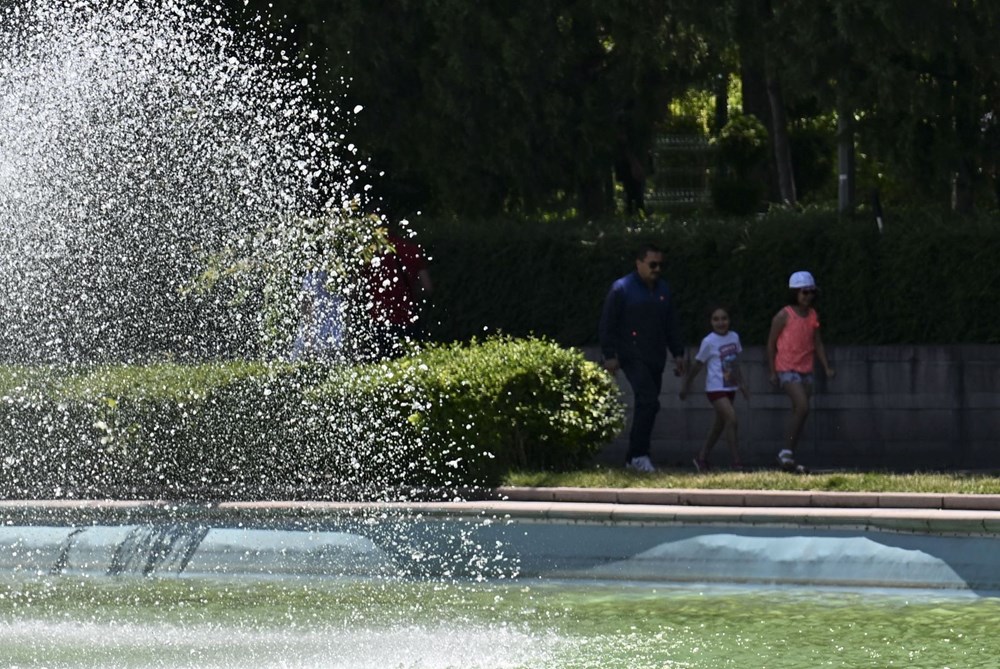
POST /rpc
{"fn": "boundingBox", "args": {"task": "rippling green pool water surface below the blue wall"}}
[0,577,1000,669]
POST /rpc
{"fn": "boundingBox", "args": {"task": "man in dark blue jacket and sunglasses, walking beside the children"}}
[599,244,685,472]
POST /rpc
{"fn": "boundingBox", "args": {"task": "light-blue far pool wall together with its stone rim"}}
[0,490,1000,592]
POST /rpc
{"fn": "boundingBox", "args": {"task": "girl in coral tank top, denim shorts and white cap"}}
[767,272,836,473]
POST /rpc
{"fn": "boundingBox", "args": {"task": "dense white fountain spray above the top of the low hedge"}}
[0,0,363,361]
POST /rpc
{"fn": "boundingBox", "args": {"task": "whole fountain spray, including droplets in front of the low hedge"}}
[0,0,480,520]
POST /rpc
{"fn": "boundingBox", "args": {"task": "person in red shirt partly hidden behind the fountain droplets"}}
[369,232,433,358]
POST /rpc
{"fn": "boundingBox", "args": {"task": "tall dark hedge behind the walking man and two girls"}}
[417,210,1000,346]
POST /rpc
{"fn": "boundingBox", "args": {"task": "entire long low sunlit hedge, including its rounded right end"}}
[0,338,623,499]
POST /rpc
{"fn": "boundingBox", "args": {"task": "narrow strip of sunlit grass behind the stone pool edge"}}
[504,467,1000,495]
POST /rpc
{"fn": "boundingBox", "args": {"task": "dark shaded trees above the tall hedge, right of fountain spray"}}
[224,0,1000,219]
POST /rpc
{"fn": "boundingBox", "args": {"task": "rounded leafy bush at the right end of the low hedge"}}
[312,337,624,485]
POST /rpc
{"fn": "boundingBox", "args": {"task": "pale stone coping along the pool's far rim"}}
[0,488,1000,534]
